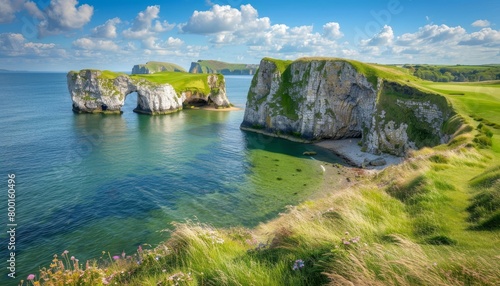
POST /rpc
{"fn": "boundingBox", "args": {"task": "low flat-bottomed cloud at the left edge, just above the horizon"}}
[0,33,66,57]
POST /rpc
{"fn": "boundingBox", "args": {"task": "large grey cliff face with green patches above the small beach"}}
[241,59,453,156]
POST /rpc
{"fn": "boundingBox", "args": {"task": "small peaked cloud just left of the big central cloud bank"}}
[123,5,175,39]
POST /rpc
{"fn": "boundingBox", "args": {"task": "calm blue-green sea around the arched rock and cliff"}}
[0,73,340,285]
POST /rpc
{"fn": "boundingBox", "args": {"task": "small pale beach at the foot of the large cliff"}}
[314,138,404,170]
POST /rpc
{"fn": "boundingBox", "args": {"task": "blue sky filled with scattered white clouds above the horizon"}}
[0,0,500,71]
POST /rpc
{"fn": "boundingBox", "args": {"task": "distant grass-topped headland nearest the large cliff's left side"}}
[189,60,259,75]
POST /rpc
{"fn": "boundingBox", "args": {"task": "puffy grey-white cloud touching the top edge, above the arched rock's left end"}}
[37,0,94,37]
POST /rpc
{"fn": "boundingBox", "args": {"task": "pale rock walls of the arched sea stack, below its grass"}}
[67,70,230,115]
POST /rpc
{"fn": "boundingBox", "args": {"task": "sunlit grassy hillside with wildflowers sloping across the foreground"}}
[28,67,500,285]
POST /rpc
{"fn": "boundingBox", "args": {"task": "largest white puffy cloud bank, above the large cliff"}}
[179,4,343,56]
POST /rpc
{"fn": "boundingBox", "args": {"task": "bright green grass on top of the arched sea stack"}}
[130,72,223,95]
